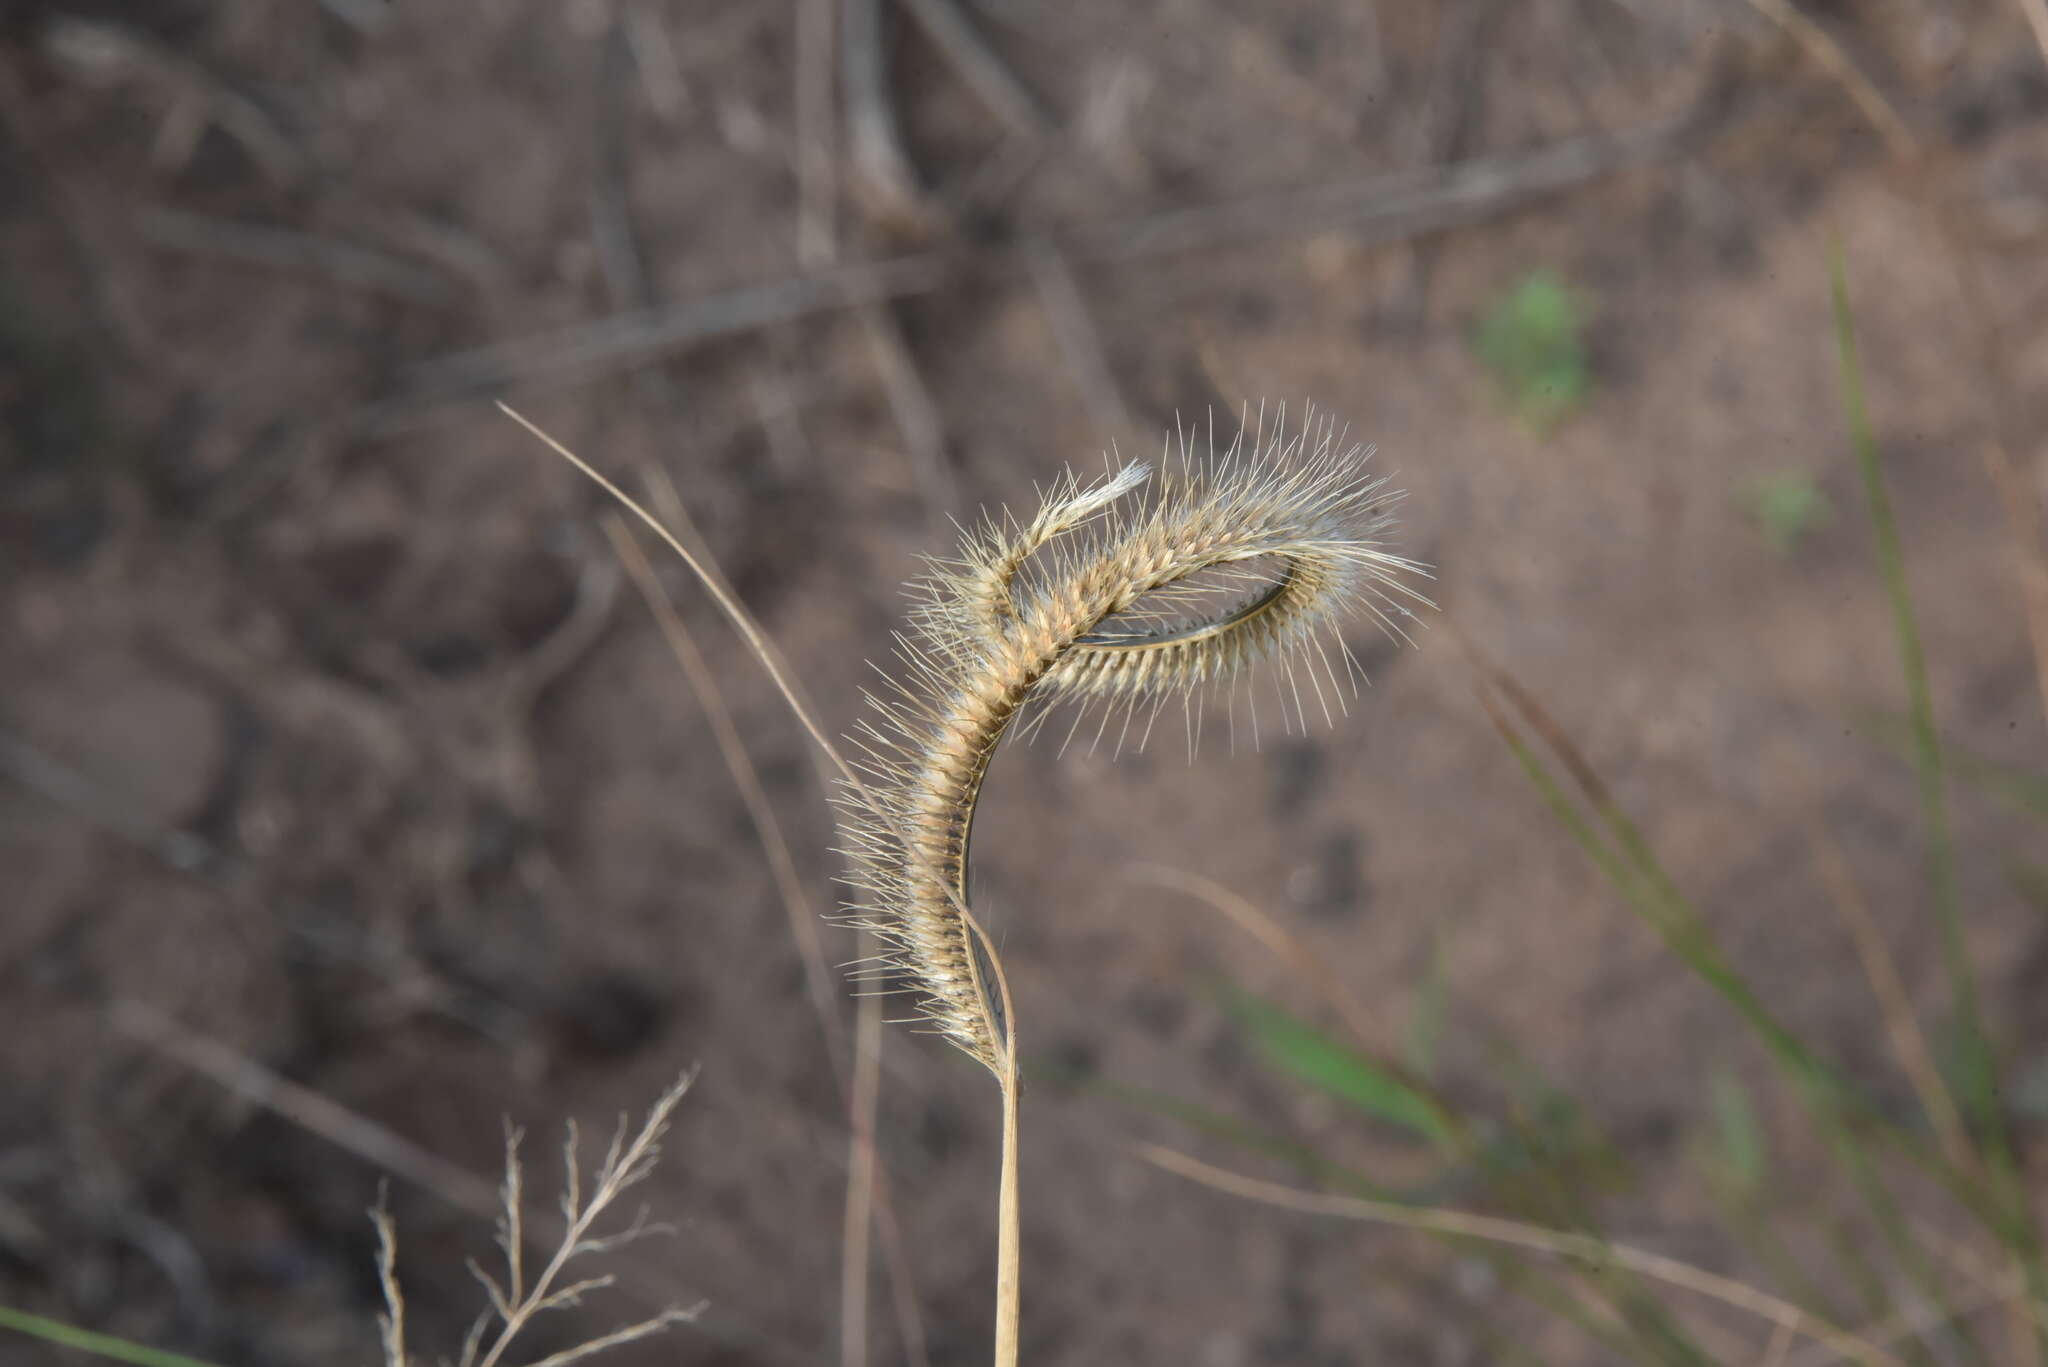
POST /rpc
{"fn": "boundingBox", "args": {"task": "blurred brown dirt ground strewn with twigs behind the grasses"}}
[0,0,2048,1367]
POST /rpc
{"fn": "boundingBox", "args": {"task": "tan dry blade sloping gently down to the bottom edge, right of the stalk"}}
[1137,1144,1905,1367]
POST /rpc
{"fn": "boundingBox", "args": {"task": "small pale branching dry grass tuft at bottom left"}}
[371,1070,702,1367]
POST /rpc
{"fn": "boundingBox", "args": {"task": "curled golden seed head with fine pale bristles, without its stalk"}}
[842,405,1427,1076]
